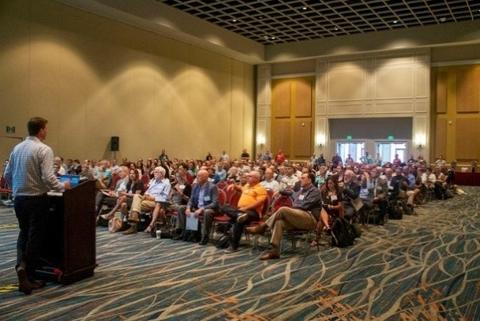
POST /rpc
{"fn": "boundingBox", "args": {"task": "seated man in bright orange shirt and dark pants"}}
[227,171,267,252]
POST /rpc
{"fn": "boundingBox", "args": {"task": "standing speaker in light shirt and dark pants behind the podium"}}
[5,117,70,295]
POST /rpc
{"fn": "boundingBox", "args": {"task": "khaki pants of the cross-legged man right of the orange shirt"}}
[265,207,317,249]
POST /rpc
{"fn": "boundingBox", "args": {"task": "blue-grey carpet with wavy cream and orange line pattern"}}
[0,188,480,321]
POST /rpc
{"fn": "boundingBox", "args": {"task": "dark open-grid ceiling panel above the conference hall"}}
[161,0,480,45]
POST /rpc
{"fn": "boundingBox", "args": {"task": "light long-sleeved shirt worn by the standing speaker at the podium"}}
[5,136,65,196]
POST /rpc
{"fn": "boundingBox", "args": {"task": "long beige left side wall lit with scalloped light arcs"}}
[0,0,254,158]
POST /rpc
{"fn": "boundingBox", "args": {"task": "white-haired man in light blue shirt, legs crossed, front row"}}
[123,166,170,234]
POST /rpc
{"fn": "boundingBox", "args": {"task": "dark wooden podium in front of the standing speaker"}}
[40,181,96,284]
